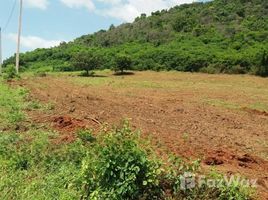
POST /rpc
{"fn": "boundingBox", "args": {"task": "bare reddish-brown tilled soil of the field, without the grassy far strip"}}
[17,75,268,199]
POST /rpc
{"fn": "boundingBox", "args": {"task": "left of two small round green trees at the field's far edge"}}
[72,52,101,76]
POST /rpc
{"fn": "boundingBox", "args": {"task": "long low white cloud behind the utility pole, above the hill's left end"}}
[8,33,62,50]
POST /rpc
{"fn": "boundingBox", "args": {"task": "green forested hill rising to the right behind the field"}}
[4,0,268,76]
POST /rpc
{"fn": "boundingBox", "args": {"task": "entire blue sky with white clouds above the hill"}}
[0,0,197,59]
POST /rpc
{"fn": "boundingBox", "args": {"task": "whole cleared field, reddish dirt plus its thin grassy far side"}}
[19,71,268,199]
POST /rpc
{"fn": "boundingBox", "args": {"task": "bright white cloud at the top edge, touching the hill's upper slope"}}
[97,0,193,22]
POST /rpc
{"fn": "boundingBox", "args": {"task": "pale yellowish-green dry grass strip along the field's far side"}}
[71,70,268,111]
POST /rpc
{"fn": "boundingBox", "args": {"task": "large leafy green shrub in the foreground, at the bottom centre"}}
[82,122,161,200]
